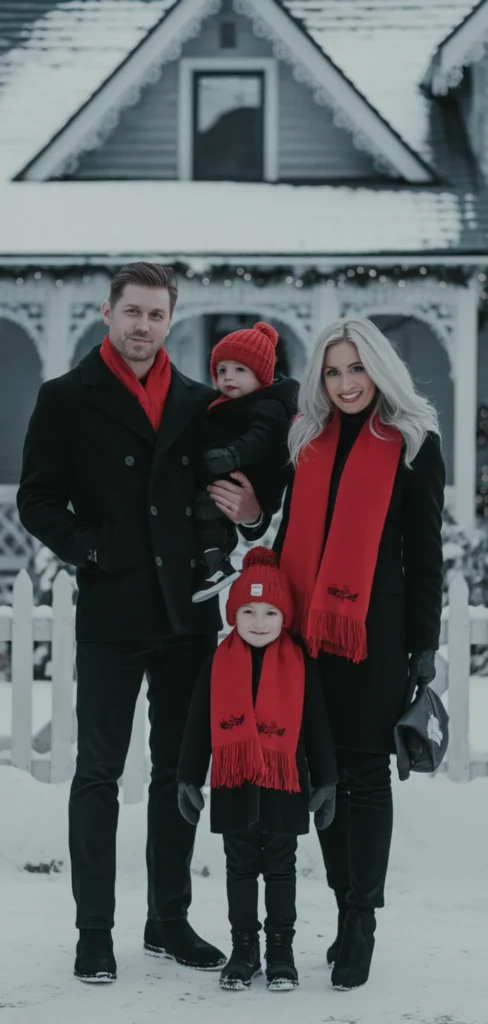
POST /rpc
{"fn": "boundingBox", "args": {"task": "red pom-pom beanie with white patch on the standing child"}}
[226,547,293,629]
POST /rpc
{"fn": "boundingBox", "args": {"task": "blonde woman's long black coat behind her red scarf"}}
[274,412,445,753]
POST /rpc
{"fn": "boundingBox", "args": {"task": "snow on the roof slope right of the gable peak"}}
[283,0,476,163]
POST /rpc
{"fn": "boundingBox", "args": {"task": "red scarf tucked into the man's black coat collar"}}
[100,334,171,432]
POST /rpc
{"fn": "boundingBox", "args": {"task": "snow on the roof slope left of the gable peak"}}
[0,0,176,179]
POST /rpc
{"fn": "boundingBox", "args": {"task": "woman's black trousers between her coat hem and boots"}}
[318,749,393,908]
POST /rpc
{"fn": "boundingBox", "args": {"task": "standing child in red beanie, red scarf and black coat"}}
[178,547,338,991]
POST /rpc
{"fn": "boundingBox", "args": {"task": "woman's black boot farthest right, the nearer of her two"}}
[331,908,376,991]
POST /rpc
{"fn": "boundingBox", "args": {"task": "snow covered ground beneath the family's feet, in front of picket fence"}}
[0,757,488,1024]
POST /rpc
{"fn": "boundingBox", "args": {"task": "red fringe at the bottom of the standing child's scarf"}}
[211,739,301,793]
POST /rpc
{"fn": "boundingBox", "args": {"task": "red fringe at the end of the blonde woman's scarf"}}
[303,611,367,665]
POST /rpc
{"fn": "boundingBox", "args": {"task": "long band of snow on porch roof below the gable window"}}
[0,181,462,254]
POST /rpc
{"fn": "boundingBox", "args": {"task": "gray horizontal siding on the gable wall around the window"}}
[73,0,378,181]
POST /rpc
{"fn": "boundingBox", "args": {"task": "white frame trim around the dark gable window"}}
[178,57,278,181]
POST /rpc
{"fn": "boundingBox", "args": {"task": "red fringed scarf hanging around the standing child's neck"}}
[210,629,305,793]
